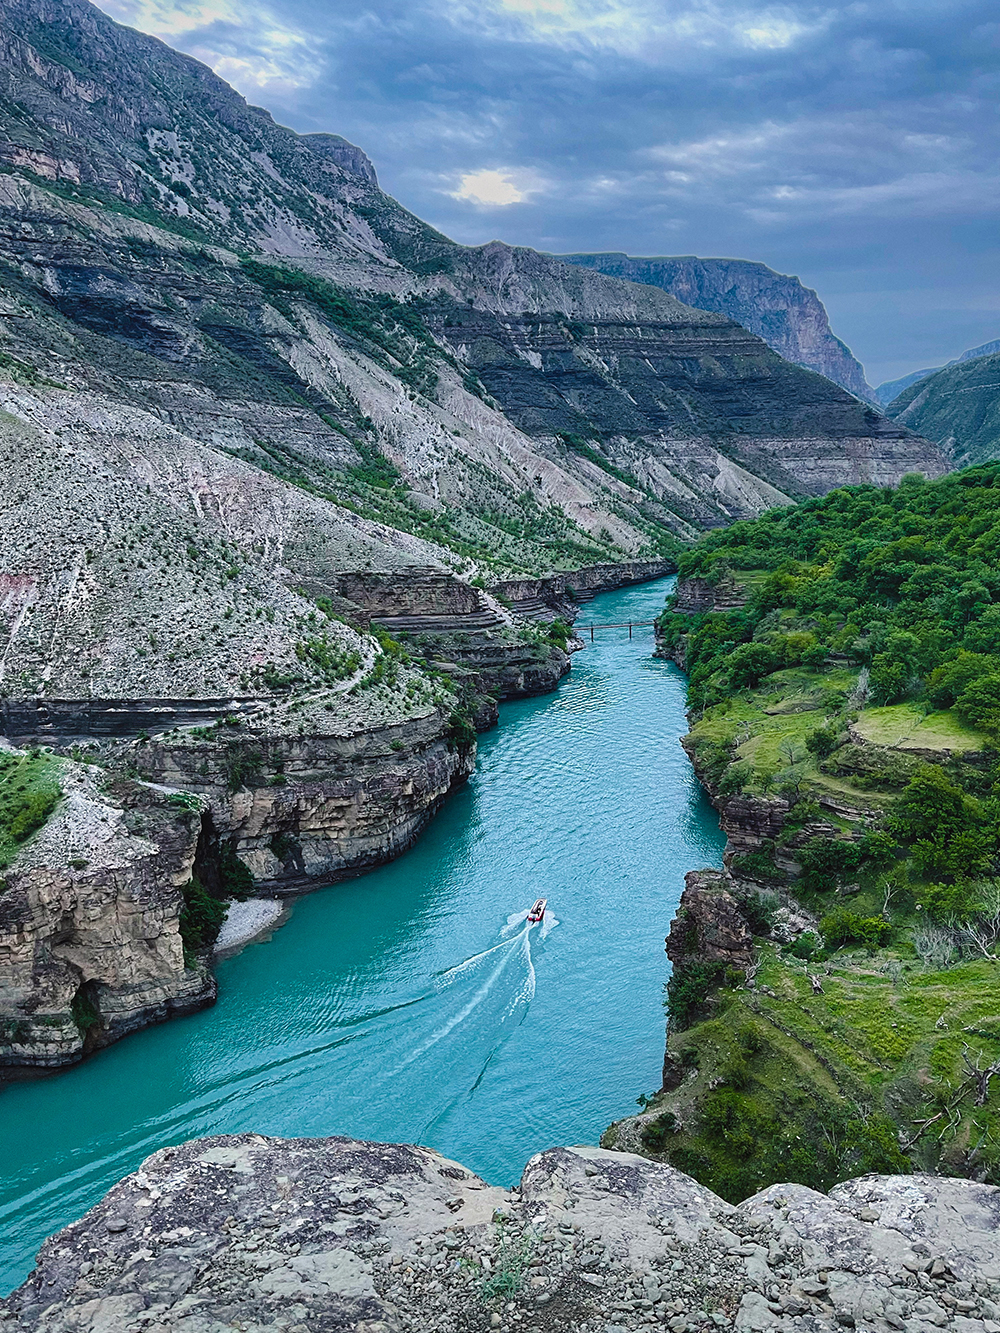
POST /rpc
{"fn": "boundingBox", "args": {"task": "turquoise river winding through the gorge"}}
[0,580,723,1292]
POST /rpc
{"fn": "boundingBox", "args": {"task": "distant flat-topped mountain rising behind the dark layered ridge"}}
[559,252,873,401]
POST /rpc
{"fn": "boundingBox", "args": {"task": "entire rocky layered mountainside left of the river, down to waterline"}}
[0,0,947,1066]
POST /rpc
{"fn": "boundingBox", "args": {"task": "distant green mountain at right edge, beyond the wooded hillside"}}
[888,343,1000,467]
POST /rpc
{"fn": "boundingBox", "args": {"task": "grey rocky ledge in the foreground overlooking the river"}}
[7,1134,1000,1333]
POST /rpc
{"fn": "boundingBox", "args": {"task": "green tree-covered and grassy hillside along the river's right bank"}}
[632,464,1000,1198]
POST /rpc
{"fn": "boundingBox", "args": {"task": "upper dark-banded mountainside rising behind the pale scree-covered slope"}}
[0,0,941,573]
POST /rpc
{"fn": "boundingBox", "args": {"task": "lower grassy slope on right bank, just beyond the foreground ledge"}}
[641,945,1000,1201]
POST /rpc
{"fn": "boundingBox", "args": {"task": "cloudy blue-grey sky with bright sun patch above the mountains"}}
[100,0,1000,384]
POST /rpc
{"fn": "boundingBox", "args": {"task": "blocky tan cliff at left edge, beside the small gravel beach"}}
[0,764,216,1068]
